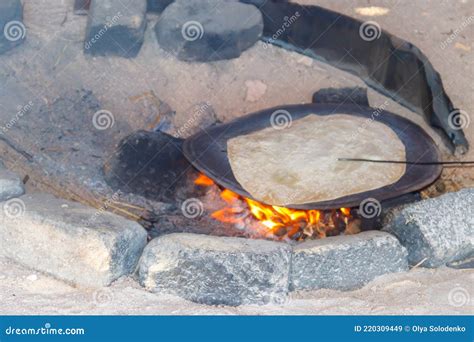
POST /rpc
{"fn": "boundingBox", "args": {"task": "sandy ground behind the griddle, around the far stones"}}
[0,0,474,190]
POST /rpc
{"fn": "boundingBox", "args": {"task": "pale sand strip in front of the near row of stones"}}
[0,259,474,315]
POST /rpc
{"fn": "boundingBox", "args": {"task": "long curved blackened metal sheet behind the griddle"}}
[241,0,469,154]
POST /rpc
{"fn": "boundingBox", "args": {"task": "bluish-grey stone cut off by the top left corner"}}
[0,0,26,55]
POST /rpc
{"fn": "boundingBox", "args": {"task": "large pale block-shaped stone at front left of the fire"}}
[0,194,147,287]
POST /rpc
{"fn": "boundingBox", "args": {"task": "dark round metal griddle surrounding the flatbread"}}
[184,104,442,210]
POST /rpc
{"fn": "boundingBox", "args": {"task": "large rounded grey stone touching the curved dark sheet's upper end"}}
[155,0,263,62]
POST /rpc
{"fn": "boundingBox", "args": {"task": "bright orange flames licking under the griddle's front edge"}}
[195,174,351,237]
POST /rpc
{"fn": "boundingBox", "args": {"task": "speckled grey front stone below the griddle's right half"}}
[290,231,408,291]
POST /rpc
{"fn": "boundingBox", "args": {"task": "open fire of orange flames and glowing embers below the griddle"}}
[195,174,358,240]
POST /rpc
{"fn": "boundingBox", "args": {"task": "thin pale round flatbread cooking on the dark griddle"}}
[227,114,406,206]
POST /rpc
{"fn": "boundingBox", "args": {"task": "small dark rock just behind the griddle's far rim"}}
[313,87,369,107]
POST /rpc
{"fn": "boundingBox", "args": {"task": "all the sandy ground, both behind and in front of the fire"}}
[0,0,474,314]
